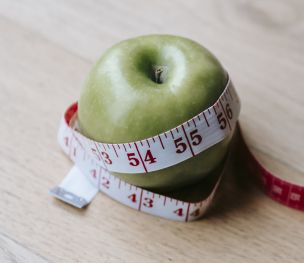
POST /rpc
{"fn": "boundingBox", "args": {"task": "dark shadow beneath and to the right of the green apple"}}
[166,126,259,219]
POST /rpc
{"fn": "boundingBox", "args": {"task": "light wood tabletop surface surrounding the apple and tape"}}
[0,0,304,263]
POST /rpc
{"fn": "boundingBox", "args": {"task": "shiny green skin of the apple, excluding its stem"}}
[78,35,230,192]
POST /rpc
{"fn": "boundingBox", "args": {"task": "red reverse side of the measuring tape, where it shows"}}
[64,102,304,211]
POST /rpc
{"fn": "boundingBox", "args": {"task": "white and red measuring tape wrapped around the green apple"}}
[50,79,304,221]
